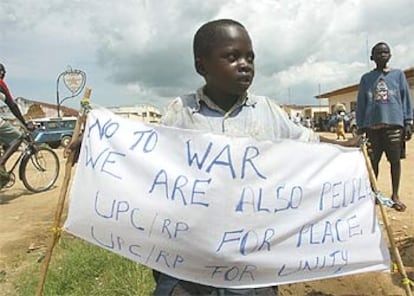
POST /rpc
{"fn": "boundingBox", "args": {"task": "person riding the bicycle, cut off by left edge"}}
[0,63,29,189]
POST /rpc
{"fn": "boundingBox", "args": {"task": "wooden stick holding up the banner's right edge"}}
[361,143,412,296]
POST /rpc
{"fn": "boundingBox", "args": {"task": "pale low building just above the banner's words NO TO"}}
[107,104,161,123]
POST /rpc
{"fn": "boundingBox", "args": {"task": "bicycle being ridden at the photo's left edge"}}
[0,131,60,193]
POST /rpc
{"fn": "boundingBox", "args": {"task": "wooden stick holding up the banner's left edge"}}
[36,87,92,296]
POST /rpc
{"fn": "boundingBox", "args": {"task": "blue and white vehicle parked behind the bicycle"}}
[32,117,76,149]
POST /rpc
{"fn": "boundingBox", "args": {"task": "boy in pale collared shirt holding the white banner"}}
[154,19,359,295]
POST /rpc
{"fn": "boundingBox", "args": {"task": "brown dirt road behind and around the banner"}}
[0,134,414,296]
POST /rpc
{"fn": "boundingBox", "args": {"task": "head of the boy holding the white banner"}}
[193,19,254,96]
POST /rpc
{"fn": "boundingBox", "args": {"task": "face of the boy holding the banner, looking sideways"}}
[196,25,254,98]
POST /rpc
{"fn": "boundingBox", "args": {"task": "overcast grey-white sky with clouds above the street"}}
[0,0,414,109]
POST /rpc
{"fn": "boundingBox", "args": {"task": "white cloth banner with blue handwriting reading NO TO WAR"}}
[65,109,390,288]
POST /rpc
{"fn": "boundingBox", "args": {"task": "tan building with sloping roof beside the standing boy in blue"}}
[315,68,414,113]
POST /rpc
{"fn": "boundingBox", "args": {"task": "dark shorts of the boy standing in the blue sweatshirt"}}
[367,127,405,162]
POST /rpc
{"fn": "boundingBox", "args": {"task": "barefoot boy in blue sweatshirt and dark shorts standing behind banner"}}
[356,42,413,212]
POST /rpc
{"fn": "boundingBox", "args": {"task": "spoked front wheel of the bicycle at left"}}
[20,147,59,192]
